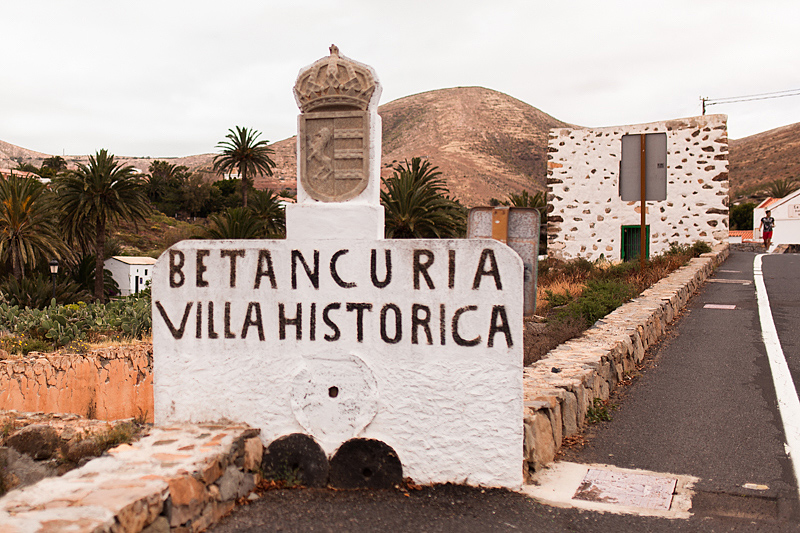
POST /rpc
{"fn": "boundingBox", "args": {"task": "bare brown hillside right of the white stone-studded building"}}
[728,123,800,193]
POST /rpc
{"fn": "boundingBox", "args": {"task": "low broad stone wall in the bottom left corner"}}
[0,425,263,533]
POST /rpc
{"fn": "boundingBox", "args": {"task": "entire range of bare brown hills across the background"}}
[0,87,800,206]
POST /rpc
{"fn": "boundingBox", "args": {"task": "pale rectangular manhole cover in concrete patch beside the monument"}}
[573,468,678,510]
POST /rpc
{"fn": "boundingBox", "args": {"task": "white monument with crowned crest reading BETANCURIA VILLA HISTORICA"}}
[153,45,523,488]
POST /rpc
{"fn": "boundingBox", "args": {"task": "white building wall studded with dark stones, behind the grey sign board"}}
[547,115,728,261]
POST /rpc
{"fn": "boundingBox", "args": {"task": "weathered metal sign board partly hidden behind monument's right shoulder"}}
[467,207,539,317]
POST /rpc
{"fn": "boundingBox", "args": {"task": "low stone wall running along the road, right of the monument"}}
[523,244,729,477]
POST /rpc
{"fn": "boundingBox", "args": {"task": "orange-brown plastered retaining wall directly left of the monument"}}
[0,342,153,422]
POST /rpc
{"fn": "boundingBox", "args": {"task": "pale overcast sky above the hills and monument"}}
[0,0,800,157]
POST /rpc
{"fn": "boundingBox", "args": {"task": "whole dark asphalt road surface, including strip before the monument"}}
[211,253,800,533]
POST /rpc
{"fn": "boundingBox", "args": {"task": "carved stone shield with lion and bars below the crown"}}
[300,111,369,202]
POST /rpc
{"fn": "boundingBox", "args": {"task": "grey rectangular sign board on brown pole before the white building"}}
[619,133,667,202]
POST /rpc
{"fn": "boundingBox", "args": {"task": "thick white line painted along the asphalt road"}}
[753,254,800,498]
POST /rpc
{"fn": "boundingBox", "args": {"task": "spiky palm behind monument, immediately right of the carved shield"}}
[381,157,467,239]
